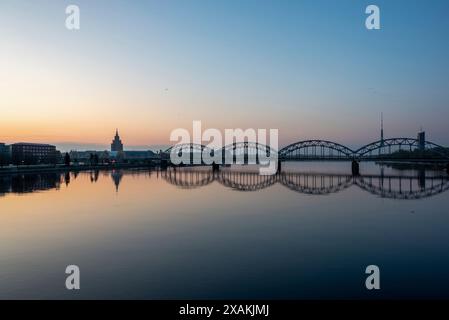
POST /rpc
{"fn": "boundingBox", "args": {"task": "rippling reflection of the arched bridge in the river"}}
[162,168,449,199]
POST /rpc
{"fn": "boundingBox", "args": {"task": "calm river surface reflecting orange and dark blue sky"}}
[0,163,449,299]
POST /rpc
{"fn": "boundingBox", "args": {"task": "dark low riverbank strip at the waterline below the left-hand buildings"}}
[0,161,159,175]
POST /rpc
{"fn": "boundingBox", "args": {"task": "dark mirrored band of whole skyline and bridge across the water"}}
[0,168,449,200]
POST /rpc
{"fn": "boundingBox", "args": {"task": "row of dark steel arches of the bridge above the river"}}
[161,138,449,164]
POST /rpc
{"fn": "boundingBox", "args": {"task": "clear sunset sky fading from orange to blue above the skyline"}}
[0,0,449,150]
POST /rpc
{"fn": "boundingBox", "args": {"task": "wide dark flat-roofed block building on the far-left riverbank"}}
[11,143,57,165]
